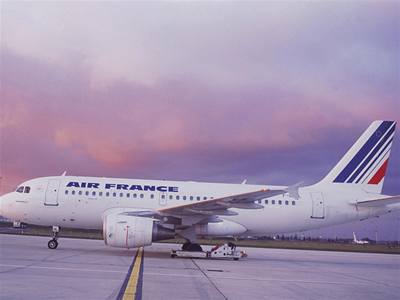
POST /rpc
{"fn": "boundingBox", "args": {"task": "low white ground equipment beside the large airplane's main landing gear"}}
[171,243,247,260]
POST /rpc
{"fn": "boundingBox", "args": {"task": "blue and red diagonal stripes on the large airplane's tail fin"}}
[333,121,396,184]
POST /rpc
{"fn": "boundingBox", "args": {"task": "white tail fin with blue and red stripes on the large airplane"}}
[320,121,396,193]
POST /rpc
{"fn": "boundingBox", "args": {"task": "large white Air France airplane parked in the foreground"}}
[0,121,400,251]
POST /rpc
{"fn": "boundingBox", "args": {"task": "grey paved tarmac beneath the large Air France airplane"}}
[0,234,400,300]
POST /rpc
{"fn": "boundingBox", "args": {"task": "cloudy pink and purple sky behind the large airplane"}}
[0,1,400,239]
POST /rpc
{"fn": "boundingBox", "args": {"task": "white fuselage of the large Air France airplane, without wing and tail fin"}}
[1,176,398,236]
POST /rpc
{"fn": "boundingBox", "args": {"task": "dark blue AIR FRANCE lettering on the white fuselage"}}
[67,181,178,193]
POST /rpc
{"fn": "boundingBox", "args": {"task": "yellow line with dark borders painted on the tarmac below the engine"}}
[117,247,144,300]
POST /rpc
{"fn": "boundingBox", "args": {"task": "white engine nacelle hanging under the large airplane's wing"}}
[103,213,175,248]
